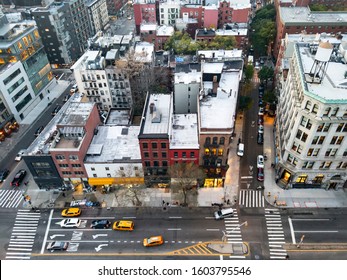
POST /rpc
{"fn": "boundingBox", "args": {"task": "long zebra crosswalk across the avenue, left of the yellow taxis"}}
[6,209,41,260]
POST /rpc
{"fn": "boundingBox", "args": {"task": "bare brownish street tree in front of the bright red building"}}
[168,162,206,206]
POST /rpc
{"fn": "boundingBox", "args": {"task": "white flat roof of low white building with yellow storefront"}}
[84,126,141,163]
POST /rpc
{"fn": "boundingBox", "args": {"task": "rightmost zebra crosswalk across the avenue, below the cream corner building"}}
[265,208,287,259]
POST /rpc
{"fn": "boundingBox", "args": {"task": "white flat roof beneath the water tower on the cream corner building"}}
[296,43,347,103]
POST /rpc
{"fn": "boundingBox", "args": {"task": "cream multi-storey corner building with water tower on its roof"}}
[275,42,347,190]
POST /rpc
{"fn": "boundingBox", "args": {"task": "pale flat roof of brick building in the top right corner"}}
[279,7,347,26]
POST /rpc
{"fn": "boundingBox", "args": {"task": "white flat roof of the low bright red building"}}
[170,114,199,149]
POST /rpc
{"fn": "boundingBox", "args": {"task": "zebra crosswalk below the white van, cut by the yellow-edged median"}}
[224,209,246,259]
